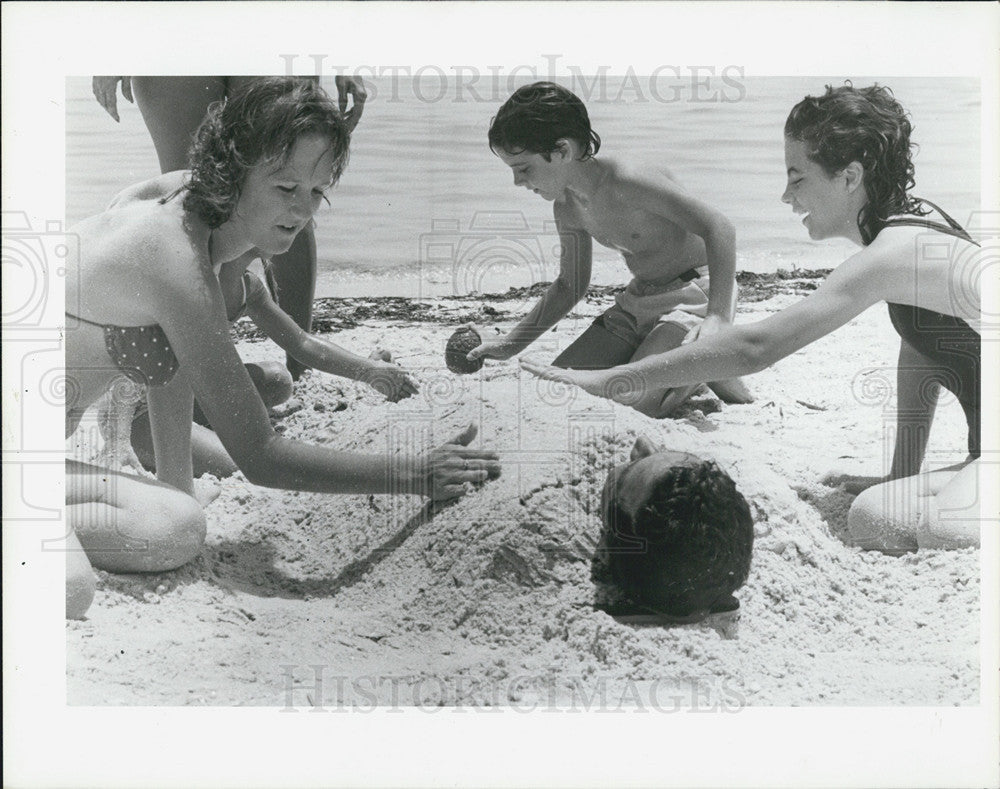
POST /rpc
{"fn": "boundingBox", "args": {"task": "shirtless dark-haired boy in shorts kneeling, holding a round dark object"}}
[468,82,753,418]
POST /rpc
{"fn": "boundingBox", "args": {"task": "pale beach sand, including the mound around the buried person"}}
[68,299,979,706]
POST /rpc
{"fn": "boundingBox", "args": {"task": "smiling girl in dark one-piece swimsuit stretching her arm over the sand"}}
[522,84,980,553]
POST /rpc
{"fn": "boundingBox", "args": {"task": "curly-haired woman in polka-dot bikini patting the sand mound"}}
[65,78,499,617]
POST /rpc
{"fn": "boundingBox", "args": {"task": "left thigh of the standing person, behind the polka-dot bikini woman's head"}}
[132,77,226,173]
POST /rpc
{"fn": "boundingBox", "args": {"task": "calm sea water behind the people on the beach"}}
[66,77,980,296]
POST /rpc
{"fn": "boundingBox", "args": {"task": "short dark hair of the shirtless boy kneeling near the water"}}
[489,82,601,161]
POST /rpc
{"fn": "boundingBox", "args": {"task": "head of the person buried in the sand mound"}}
[592,437,753,625]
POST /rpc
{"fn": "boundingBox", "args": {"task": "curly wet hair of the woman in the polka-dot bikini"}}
[183,77,350,228]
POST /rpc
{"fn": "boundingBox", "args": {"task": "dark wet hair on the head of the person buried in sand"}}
[595,461,753,616]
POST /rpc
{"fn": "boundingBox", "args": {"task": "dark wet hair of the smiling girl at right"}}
[785,82,928,244]
